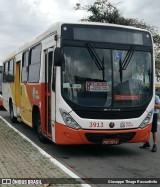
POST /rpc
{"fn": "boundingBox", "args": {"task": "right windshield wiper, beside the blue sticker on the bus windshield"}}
[119,46,135,84]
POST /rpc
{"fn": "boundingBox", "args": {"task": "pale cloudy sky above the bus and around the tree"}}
[0,0,160,64]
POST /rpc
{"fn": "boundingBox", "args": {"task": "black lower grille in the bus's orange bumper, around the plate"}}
[85,132,136,143]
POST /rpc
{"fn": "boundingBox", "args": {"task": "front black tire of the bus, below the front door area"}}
[36,112,47,143]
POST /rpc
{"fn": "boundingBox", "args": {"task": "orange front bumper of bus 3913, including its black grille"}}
[54,123,151,145]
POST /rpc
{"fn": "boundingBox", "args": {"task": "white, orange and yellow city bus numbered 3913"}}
[2,22,155,144]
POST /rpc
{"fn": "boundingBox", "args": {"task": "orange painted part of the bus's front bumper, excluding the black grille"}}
[55,123,151,144]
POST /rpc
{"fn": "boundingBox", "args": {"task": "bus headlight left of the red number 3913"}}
[59,108,81,129]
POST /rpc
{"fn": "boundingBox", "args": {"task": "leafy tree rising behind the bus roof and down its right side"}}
[74,0,160,80]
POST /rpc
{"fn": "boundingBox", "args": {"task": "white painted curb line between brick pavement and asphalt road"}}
[0,117,91,187]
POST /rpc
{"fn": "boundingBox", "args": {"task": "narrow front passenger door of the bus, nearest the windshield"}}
[45,48,54,138]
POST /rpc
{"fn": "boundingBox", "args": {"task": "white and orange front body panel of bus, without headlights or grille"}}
[53,76,154,144]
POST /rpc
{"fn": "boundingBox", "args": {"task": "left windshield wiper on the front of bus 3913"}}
[86,42,105,80]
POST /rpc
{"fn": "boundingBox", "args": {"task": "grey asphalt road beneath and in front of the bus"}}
[0,107,160,187]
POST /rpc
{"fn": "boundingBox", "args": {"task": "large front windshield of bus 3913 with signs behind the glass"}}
[62,46,153,108]
